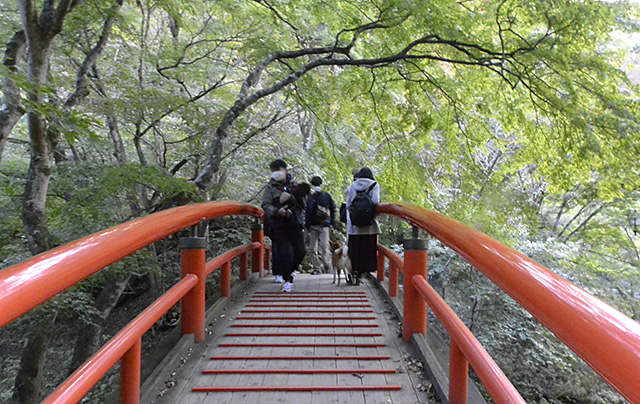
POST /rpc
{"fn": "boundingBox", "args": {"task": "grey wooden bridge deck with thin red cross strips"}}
[177,275,432,404]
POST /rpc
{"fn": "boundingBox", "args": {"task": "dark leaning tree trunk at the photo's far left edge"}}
[0,31,27,166]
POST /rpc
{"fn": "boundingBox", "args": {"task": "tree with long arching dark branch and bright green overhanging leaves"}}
[195,1,637,200]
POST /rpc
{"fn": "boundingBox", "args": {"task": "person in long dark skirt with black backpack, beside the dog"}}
[345,167,381,285]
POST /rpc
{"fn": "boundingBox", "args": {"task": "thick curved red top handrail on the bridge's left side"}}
[0,202,263,327]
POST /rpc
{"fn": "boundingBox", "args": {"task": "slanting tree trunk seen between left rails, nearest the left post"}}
[68,273,131,374]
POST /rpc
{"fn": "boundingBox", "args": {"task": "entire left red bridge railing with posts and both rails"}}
[0,202,269,404]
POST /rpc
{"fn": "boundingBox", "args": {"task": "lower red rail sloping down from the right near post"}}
[412,276,526,404]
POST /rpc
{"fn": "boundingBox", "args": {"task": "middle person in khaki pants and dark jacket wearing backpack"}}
[305,176,336,275]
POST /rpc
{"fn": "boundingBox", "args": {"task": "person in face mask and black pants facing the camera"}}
[262,159,308,292]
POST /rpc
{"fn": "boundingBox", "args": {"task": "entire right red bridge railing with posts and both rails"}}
[378,204,640,404]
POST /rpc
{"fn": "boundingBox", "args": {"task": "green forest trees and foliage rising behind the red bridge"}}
[0,0,640,402]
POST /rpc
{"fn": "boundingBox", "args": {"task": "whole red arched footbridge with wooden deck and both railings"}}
[0,202,640,404]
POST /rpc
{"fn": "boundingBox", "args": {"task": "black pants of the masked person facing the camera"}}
[271,224,307,282]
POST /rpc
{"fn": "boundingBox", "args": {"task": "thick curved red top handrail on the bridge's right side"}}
[378,204,640,403]
